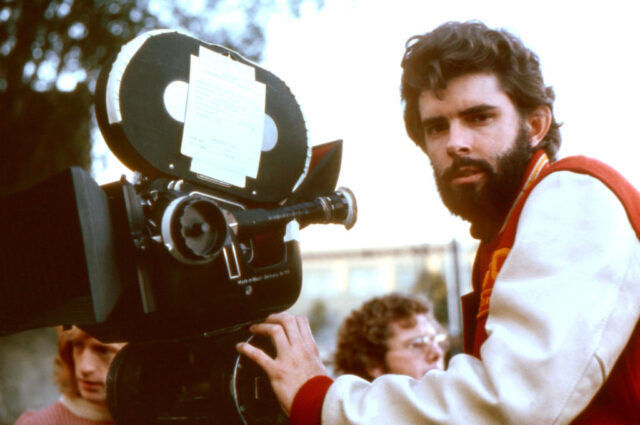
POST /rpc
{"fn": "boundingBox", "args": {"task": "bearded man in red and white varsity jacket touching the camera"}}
[238,22,640,425]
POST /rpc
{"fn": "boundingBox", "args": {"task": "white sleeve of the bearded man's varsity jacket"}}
[322,172,640,425]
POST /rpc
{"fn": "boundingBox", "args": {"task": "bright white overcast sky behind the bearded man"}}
[91,0,640,251]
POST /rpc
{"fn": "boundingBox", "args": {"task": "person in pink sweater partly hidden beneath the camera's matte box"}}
[15,327,124,425]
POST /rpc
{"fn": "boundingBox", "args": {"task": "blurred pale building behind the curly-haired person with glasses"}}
[289,240,476,364]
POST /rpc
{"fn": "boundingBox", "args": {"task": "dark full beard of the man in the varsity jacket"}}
[434,122,532,239]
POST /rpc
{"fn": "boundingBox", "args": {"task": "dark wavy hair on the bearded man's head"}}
[401,21,561,161]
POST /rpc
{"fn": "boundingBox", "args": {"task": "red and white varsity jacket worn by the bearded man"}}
[292,152,640,425]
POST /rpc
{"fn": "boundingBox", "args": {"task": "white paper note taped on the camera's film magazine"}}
[181,47,266,187]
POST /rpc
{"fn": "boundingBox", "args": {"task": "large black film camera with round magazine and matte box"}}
[0,31,357,425]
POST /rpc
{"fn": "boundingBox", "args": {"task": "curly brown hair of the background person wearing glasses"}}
[334,293,435,381]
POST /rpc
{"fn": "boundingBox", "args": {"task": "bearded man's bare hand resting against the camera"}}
[237,313,327,414]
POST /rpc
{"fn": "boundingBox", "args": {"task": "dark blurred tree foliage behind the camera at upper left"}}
[0,0,324,194]
